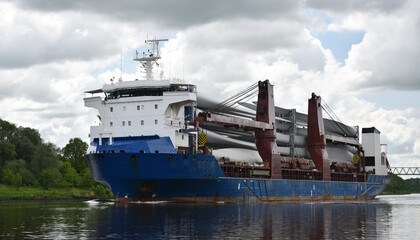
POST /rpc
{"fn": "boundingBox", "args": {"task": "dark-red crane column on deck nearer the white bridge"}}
[255,80,281,178]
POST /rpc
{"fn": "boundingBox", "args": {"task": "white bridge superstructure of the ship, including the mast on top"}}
[84,39,197,149]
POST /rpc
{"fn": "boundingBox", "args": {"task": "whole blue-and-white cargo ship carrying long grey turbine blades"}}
[84,39,391,202]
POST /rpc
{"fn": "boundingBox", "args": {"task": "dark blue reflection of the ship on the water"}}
[88,203,391,239]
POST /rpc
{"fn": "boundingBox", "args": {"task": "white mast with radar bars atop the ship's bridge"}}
[133,39,168,80]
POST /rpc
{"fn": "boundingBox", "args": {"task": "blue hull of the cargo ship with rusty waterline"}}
[87,153,391,202]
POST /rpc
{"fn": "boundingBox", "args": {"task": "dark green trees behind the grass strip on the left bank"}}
[0,119,107,195]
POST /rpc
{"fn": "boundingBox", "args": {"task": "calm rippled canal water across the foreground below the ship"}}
[0,194,420,239]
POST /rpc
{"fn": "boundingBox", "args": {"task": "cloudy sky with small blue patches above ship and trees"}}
[0,0,420,169]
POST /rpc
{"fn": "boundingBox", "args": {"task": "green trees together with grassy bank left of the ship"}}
[0,119,113,199]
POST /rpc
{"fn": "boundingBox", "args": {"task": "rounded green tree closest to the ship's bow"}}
[63,138,88,173]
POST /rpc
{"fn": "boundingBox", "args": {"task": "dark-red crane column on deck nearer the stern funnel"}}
[308,93,331,181]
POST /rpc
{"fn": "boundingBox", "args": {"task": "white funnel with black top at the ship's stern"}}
[362,127,387,175]
